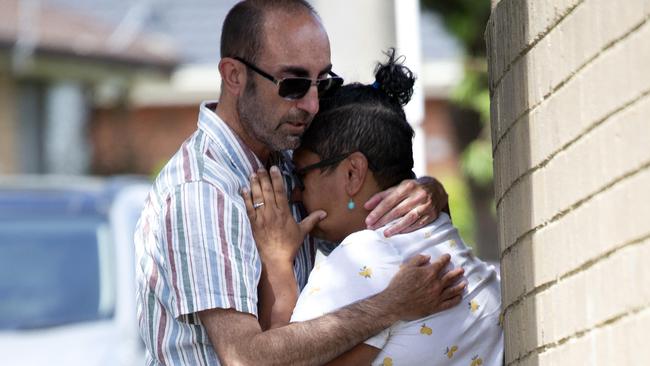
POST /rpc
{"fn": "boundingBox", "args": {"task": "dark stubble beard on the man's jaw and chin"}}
[237,80,311,151]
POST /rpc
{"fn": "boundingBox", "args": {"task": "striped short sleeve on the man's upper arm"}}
[160,182,261,318]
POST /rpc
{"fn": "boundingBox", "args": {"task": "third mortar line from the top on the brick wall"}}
[493,83,650,208]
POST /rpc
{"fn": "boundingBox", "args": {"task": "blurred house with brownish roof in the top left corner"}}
[0,0,176,174]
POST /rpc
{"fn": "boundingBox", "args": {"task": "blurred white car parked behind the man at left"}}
[0,176,150,366]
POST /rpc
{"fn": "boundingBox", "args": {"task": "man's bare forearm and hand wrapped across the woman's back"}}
[199,256,464,365]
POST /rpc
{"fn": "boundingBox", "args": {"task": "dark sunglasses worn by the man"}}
[233,57,343,100]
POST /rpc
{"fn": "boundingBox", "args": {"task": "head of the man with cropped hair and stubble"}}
[220,0,331,156]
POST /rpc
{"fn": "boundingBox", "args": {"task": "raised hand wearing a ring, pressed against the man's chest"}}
[242,166,326,263]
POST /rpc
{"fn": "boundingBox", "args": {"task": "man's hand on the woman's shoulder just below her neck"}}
[364,177,449,237]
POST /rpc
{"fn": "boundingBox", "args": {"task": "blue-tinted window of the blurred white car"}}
[0,216,114,329]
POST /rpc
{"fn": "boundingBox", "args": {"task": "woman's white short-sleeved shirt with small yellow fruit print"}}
[291,213,503,365]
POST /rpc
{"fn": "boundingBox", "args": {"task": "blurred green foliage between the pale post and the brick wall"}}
[420,0,495,254]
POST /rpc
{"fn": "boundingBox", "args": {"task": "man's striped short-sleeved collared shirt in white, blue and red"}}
[135,103,315,365]
